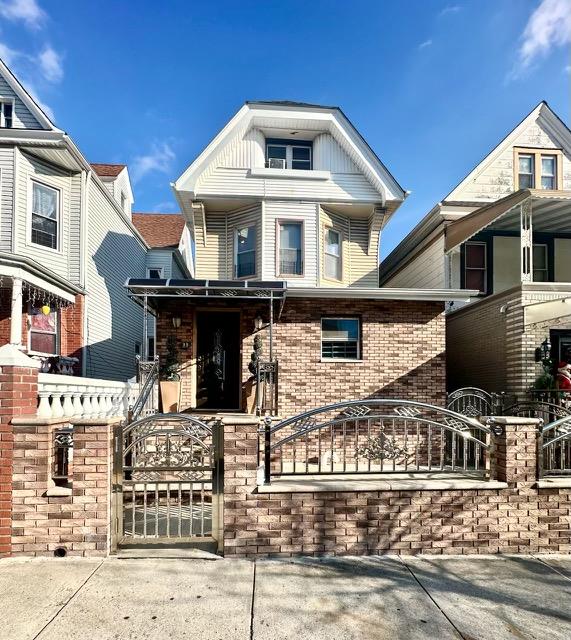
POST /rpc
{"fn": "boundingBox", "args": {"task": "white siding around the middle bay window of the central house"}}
[262,200,318,287]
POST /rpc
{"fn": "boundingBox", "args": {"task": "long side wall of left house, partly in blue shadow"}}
[85,181,146,380]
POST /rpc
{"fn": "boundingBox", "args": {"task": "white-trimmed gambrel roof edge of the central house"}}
[173,100,406,204]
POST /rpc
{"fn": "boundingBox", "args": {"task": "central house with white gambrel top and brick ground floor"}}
[124,102,466,415]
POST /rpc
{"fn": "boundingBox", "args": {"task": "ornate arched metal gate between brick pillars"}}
[114,414,223,552]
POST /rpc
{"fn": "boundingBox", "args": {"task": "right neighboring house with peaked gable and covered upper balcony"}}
[380,102,571,395]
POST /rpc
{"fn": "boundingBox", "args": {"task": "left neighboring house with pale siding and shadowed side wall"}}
[0,61,147,379]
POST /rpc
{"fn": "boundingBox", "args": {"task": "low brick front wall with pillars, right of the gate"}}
[224,424,571,557]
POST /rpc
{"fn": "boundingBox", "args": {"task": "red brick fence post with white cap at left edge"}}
[0,344,39,558]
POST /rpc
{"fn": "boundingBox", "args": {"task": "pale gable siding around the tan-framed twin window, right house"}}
[447,116,571,202]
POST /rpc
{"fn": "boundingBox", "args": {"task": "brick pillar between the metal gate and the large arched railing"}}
[224,416,260,556]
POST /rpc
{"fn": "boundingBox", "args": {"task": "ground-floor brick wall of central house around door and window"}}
[157,298,446,416]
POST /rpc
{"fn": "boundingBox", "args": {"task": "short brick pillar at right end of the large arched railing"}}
[491,417,540,486]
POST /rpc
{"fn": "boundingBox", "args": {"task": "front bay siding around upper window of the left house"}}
[15,152,72,280]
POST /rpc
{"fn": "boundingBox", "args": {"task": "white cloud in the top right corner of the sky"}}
[518,0,571,71]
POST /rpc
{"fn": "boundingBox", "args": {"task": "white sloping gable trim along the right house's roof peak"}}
[444,102,571,201]
